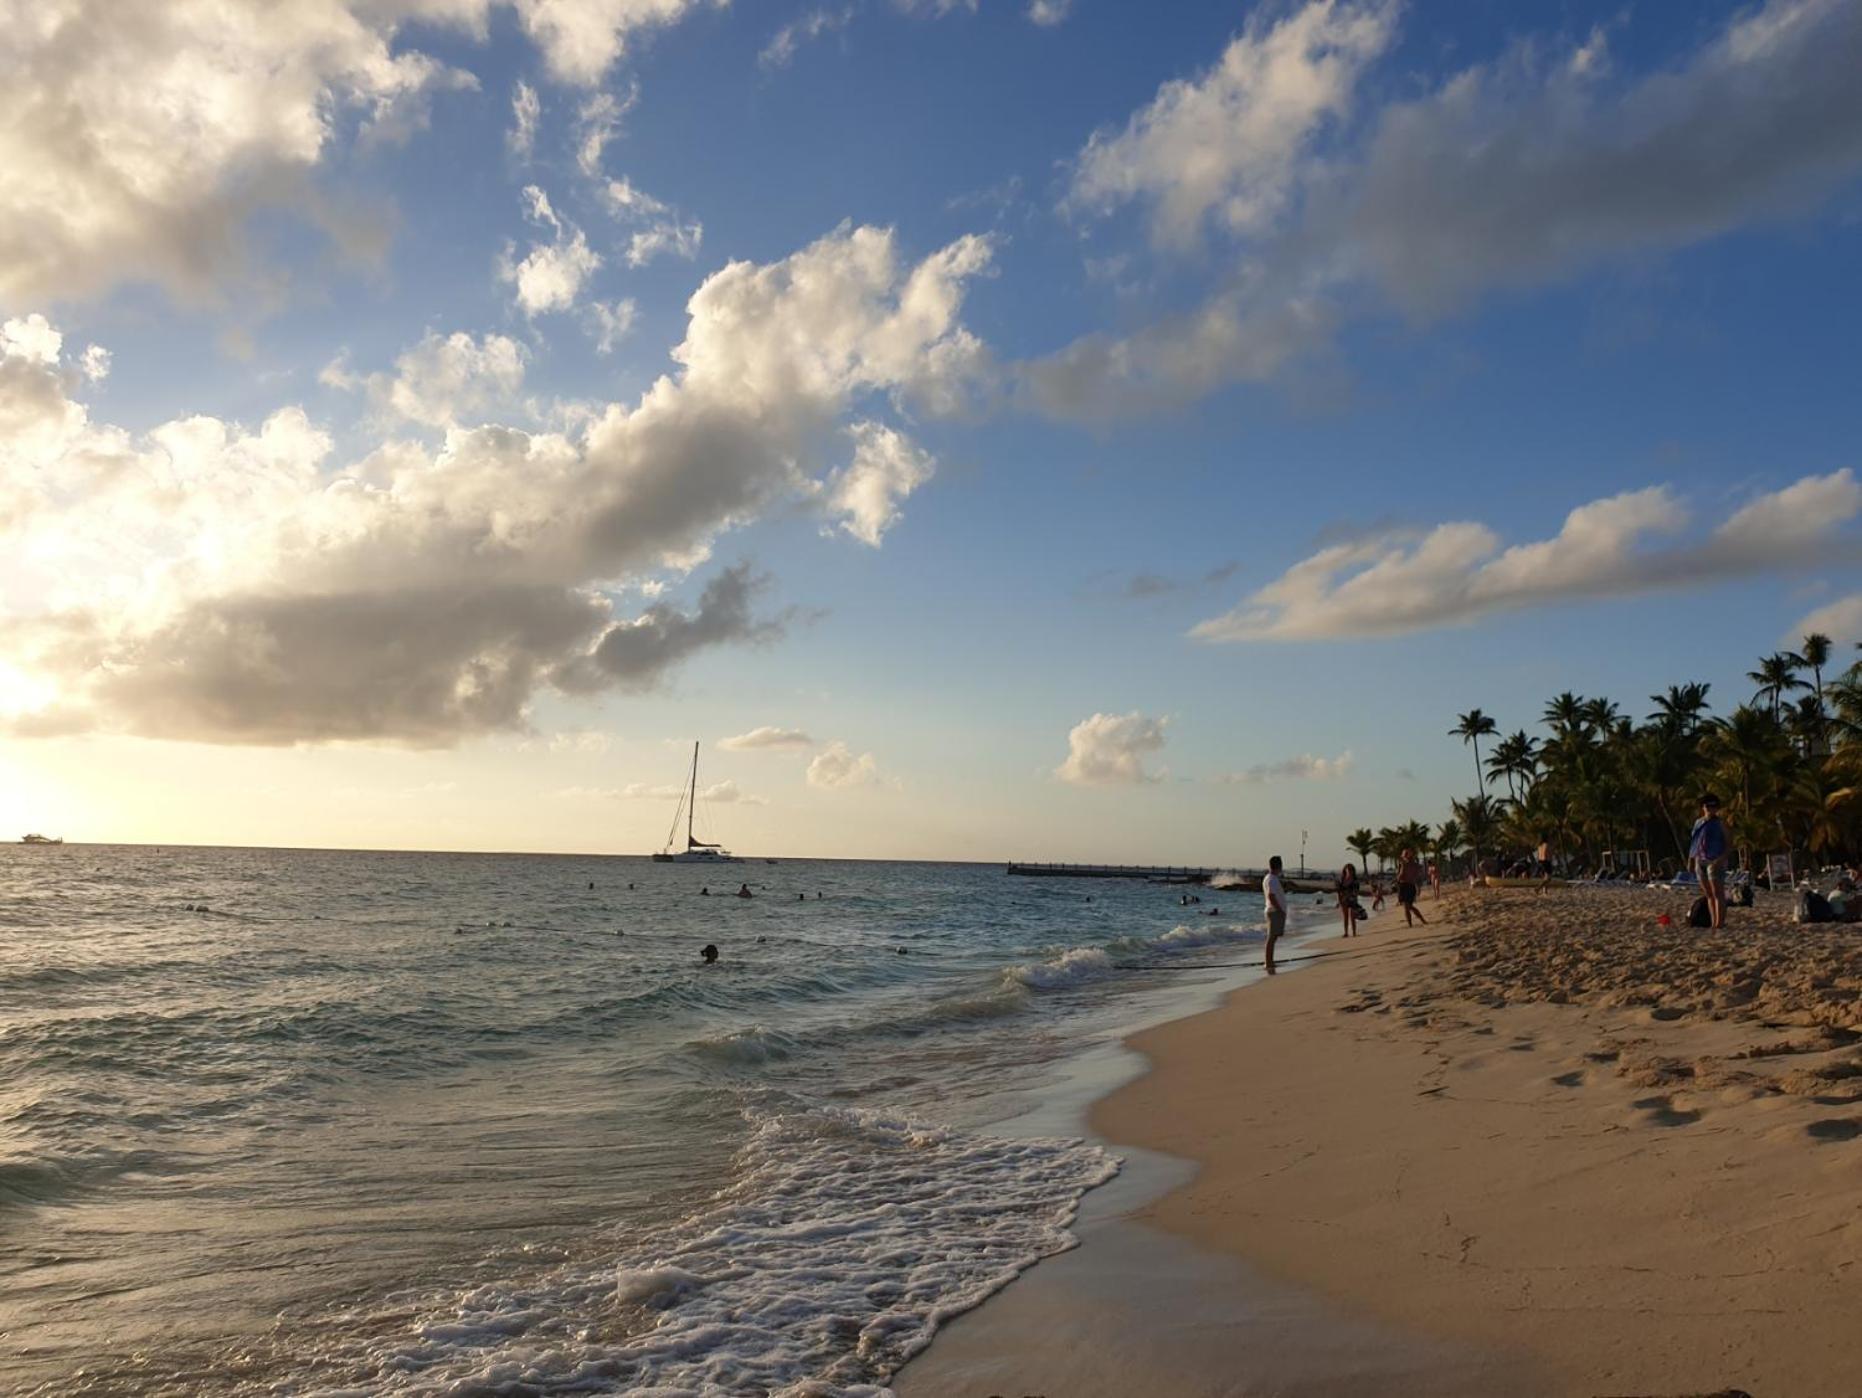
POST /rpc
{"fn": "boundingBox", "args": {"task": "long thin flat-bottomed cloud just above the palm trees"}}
[1192,469,1862,640]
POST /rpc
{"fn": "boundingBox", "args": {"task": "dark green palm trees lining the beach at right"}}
[1346,633,1862,869]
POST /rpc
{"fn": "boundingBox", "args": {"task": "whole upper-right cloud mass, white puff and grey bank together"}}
[1020,0,1862,421]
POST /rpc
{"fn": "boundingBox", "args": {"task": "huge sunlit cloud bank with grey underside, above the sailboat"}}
[0,229,987,745]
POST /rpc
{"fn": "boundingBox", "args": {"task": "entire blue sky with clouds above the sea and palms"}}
[0,0,1862,866]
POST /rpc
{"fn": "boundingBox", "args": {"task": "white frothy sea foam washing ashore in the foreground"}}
[323,1102,1119,1398]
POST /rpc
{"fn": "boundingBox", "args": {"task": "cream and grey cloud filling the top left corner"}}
[0,0,471,305]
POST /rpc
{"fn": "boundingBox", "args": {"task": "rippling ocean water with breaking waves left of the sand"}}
[0,845,1288,1398]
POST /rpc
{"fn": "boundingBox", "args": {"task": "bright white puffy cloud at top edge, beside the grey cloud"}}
[1069,0,1395,246]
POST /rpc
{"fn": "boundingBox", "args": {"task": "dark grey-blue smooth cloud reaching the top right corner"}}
[1340,0,1862,313]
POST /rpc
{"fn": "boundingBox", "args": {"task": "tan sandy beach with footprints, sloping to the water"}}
[901,888,1862,1398]
